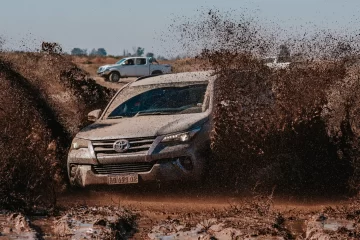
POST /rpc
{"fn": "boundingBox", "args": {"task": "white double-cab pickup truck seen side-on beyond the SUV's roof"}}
[97,57,171,82]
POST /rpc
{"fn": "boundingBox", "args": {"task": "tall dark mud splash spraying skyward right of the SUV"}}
[167,10,360,195]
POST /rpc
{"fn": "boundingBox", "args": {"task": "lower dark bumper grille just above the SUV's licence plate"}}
[92,162,154,174]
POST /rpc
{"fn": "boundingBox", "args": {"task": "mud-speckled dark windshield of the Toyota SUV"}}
[106,83,207,119]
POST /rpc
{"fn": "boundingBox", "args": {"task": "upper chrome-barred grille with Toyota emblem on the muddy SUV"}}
[92,137,155,157]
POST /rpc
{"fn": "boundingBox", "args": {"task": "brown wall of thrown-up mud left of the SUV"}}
[0,53,113,209]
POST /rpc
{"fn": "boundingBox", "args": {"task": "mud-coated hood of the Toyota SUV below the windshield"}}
[76,112,209,140]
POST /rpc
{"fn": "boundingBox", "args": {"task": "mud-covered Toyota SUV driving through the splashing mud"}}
[67,72,215,187]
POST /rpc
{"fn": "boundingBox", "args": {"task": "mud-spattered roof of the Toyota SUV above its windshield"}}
[130,71,215,86]
